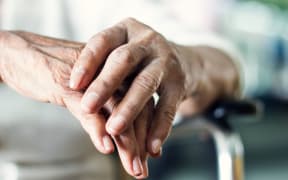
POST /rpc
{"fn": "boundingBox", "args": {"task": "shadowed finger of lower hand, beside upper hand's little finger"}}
[134,99,154,179]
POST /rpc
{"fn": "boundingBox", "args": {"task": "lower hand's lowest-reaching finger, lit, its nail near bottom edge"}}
[114,127,143,177]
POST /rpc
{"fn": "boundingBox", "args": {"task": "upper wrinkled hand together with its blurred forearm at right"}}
[70,18,239,158]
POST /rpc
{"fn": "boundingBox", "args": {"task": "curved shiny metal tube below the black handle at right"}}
[171,118,244,180]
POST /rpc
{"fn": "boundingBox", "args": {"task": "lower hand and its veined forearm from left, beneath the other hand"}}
[0,32,153,178]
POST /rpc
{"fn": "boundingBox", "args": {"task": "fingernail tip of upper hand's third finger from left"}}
[107,115,126,135]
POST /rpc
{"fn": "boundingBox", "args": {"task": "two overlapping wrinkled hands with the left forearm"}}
[0,18,205,179]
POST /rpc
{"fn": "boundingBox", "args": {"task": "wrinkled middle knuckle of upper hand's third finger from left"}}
[135,73,160,92]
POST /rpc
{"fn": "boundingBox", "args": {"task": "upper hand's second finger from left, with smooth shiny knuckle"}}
[82,44,147,112]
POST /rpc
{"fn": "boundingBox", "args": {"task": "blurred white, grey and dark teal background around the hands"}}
[0,0,288,180]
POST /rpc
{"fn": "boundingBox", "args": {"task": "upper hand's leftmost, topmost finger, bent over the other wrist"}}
[70,25,126,90]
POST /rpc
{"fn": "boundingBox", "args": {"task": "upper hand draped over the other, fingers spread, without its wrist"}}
[70,19,185,155]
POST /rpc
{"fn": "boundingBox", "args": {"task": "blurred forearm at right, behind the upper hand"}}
[173,45,240,109]
